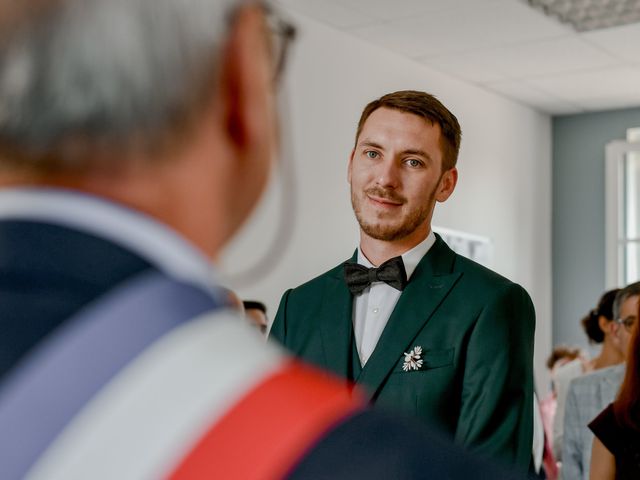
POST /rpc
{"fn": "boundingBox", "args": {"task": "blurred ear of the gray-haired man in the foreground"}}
[218,6,273,153]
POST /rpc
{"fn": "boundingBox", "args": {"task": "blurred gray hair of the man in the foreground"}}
[0,0,238,170]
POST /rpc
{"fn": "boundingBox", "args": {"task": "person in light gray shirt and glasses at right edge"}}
[560,282,640,480]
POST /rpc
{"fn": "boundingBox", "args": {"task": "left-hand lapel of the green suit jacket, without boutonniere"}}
[319,250,357,378]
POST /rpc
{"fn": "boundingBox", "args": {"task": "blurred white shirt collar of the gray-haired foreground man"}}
[0,188,218,295]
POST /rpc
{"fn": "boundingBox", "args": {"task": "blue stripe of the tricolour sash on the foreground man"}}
[0,272,223,480]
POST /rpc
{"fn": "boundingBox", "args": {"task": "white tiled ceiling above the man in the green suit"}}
[278,0,640,114]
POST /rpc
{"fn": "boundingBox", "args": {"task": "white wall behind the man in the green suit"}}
[222,12,551,392]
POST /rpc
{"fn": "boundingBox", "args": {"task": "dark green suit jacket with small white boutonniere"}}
[271,236,535,470]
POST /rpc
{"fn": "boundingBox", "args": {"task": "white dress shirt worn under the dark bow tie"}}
[353,232,436,366]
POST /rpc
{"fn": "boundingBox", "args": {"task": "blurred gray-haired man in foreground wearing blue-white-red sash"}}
[0,0,524,479]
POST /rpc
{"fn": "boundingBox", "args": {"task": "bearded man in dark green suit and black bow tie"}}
[271,91,535,470]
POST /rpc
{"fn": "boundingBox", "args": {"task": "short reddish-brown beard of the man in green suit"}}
[351,187,436,242]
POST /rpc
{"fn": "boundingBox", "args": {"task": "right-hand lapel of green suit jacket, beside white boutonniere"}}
[357,236,461,398]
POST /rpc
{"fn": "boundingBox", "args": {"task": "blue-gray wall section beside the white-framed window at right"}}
[552,108,640,347]
